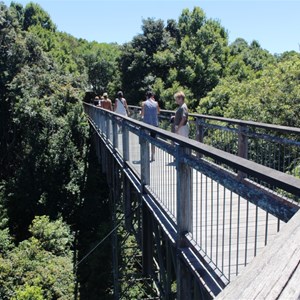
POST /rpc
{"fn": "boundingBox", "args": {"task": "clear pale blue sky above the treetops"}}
[4,0,300,53]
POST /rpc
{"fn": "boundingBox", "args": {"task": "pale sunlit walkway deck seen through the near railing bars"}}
[119,132,285,281]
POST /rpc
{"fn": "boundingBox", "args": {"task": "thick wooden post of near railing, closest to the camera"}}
[175,145,193,300]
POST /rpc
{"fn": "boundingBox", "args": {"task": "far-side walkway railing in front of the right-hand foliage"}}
[129,106,300,177]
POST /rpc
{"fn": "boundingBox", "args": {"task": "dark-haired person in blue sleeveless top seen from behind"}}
[141,91,160,161]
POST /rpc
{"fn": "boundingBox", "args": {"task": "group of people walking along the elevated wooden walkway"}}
[94,91,189,161]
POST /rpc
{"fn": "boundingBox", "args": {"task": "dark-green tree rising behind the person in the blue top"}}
[120,18,174,103]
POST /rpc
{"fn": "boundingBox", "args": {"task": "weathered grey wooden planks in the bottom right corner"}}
[216,212,300,300]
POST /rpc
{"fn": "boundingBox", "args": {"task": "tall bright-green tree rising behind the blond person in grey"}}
[177,7,228,109]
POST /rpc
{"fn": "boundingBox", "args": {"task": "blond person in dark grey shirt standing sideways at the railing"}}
[174,91,190,137]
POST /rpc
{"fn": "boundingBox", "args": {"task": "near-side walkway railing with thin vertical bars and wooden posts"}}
[84,104,300,288]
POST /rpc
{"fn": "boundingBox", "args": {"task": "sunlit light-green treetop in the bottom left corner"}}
[0,216,74,300]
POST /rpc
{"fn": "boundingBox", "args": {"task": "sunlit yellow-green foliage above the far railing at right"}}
[199,54,300,127]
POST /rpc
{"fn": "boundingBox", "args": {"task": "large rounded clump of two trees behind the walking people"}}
[120,8,228,110]
